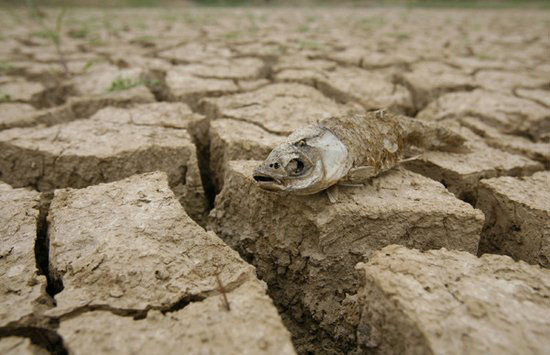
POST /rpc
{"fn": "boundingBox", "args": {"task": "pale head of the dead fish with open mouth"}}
[253,126,349,195]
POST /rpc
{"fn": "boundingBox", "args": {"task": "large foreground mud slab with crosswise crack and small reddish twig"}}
[48,172,294,354]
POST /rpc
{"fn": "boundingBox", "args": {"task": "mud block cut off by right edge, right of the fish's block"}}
[476,171,550,268]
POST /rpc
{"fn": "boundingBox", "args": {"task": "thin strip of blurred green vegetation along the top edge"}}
[0,0,550,8]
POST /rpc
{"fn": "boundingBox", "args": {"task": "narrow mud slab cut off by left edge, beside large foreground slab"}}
[0,183,50,334]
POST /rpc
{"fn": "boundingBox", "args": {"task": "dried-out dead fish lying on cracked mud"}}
[253,110,465,202]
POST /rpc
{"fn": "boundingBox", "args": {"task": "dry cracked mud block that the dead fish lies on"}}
[210,161,483,354]
